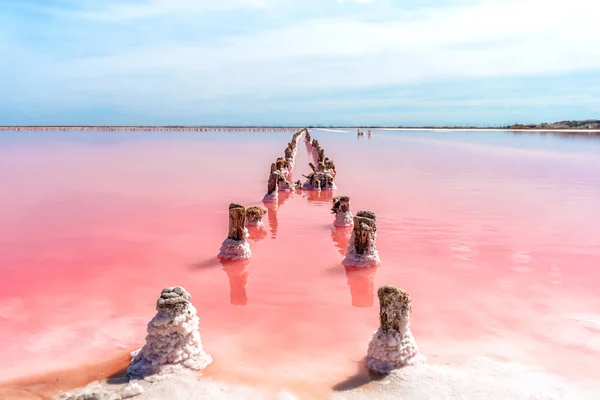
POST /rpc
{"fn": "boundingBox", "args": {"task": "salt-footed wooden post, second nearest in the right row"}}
[342,210,381,267]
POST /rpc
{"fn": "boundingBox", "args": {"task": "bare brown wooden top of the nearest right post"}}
[377,286,411,333]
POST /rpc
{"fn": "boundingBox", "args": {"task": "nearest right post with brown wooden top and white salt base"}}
[366,286,424,374]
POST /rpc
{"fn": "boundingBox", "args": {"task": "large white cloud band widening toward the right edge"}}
[38,0,600,97]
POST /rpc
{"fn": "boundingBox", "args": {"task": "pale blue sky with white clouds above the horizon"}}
[0,0,600,125]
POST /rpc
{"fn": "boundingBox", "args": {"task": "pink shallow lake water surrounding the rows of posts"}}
[0,130,600,396]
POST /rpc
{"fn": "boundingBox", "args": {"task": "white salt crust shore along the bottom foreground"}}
[54,358,600,400]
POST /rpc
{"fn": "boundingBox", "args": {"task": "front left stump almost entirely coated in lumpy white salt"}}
[127,286,212,376]
